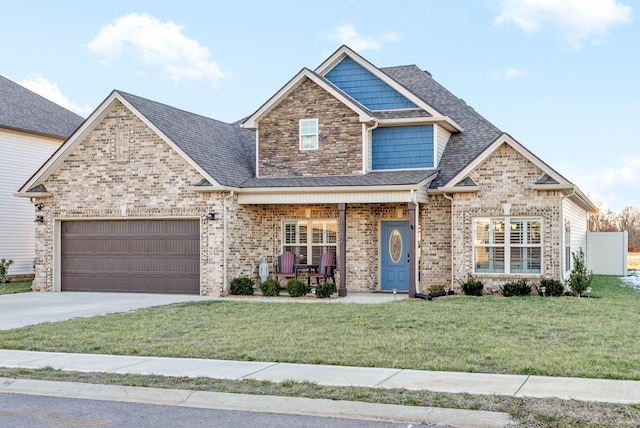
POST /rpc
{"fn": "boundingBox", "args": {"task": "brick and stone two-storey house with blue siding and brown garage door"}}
[18,46,595,295]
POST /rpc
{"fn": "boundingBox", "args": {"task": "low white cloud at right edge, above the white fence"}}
[571,155,640,212]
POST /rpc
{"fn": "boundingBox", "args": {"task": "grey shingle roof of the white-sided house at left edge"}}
[0,76,84,140]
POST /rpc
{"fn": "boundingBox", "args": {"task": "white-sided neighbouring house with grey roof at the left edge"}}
[0,76,84,276]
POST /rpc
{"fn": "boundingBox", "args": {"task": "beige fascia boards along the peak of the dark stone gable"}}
[242,68,373,129]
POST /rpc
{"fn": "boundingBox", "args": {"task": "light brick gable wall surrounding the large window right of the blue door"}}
[452,144,561,293]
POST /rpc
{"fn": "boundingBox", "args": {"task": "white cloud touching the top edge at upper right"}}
[494,0,633,49]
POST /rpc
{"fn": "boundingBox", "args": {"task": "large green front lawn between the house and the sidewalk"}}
[0,276,640,380]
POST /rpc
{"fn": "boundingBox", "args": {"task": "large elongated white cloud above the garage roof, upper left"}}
[88,13,225,87]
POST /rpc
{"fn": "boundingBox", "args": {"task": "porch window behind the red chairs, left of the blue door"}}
[282,220,338,265]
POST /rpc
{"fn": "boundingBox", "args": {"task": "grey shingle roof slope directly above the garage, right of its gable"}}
[117,91,255,186]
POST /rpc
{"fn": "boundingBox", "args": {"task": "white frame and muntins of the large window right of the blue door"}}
[471,216,544,276]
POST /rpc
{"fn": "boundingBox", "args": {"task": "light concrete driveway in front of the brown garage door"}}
[0,292,213,330]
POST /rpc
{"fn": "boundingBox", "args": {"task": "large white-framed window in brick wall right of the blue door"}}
[473,218,542,274]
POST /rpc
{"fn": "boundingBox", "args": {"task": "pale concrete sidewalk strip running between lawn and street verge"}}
[0,350,640,404]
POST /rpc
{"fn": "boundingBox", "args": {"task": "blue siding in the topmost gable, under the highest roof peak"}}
[324,57,416,110]
